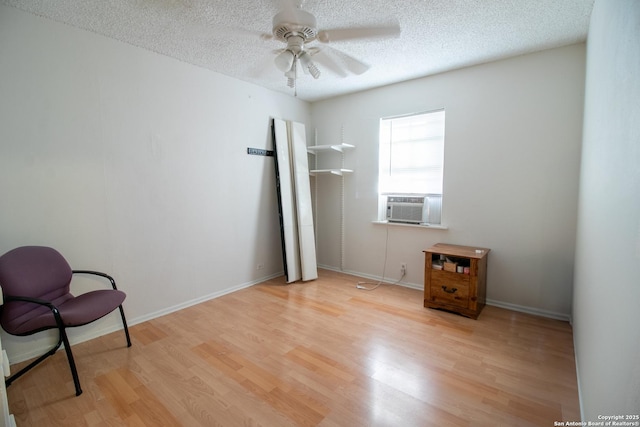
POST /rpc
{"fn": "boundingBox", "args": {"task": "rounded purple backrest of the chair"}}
[0,246,72,317]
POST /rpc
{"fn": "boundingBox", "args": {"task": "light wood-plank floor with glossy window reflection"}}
[7,270,580,427]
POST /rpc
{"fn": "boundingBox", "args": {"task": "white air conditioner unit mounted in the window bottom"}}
[386,194,442,224]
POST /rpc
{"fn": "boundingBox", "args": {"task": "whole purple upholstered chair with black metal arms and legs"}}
[0,246,131,396]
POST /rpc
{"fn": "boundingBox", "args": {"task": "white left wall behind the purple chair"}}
[0,6,309,362]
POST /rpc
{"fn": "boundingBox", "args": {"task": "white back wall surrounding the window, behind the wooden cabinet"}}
[311,44,585,319]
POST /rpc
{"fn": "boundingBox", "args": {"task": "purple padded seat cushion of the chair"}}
[3,289,126,335]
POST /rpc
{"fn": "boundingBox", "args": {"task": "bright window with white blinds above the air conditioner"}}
[378,110,445,224]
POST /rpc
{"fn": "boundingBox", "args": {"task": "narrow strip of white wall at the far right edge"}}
[573,0,640,422]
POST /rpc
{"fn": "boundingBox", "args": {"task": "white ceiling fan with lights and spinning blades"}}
[261,0,400,89]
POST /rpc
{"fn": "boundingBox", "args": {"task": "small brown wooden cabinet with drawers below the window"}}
[424,243,490,319]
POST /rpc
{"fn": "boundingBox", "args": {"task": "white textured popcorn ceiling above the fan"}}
[0,0,594,101]
